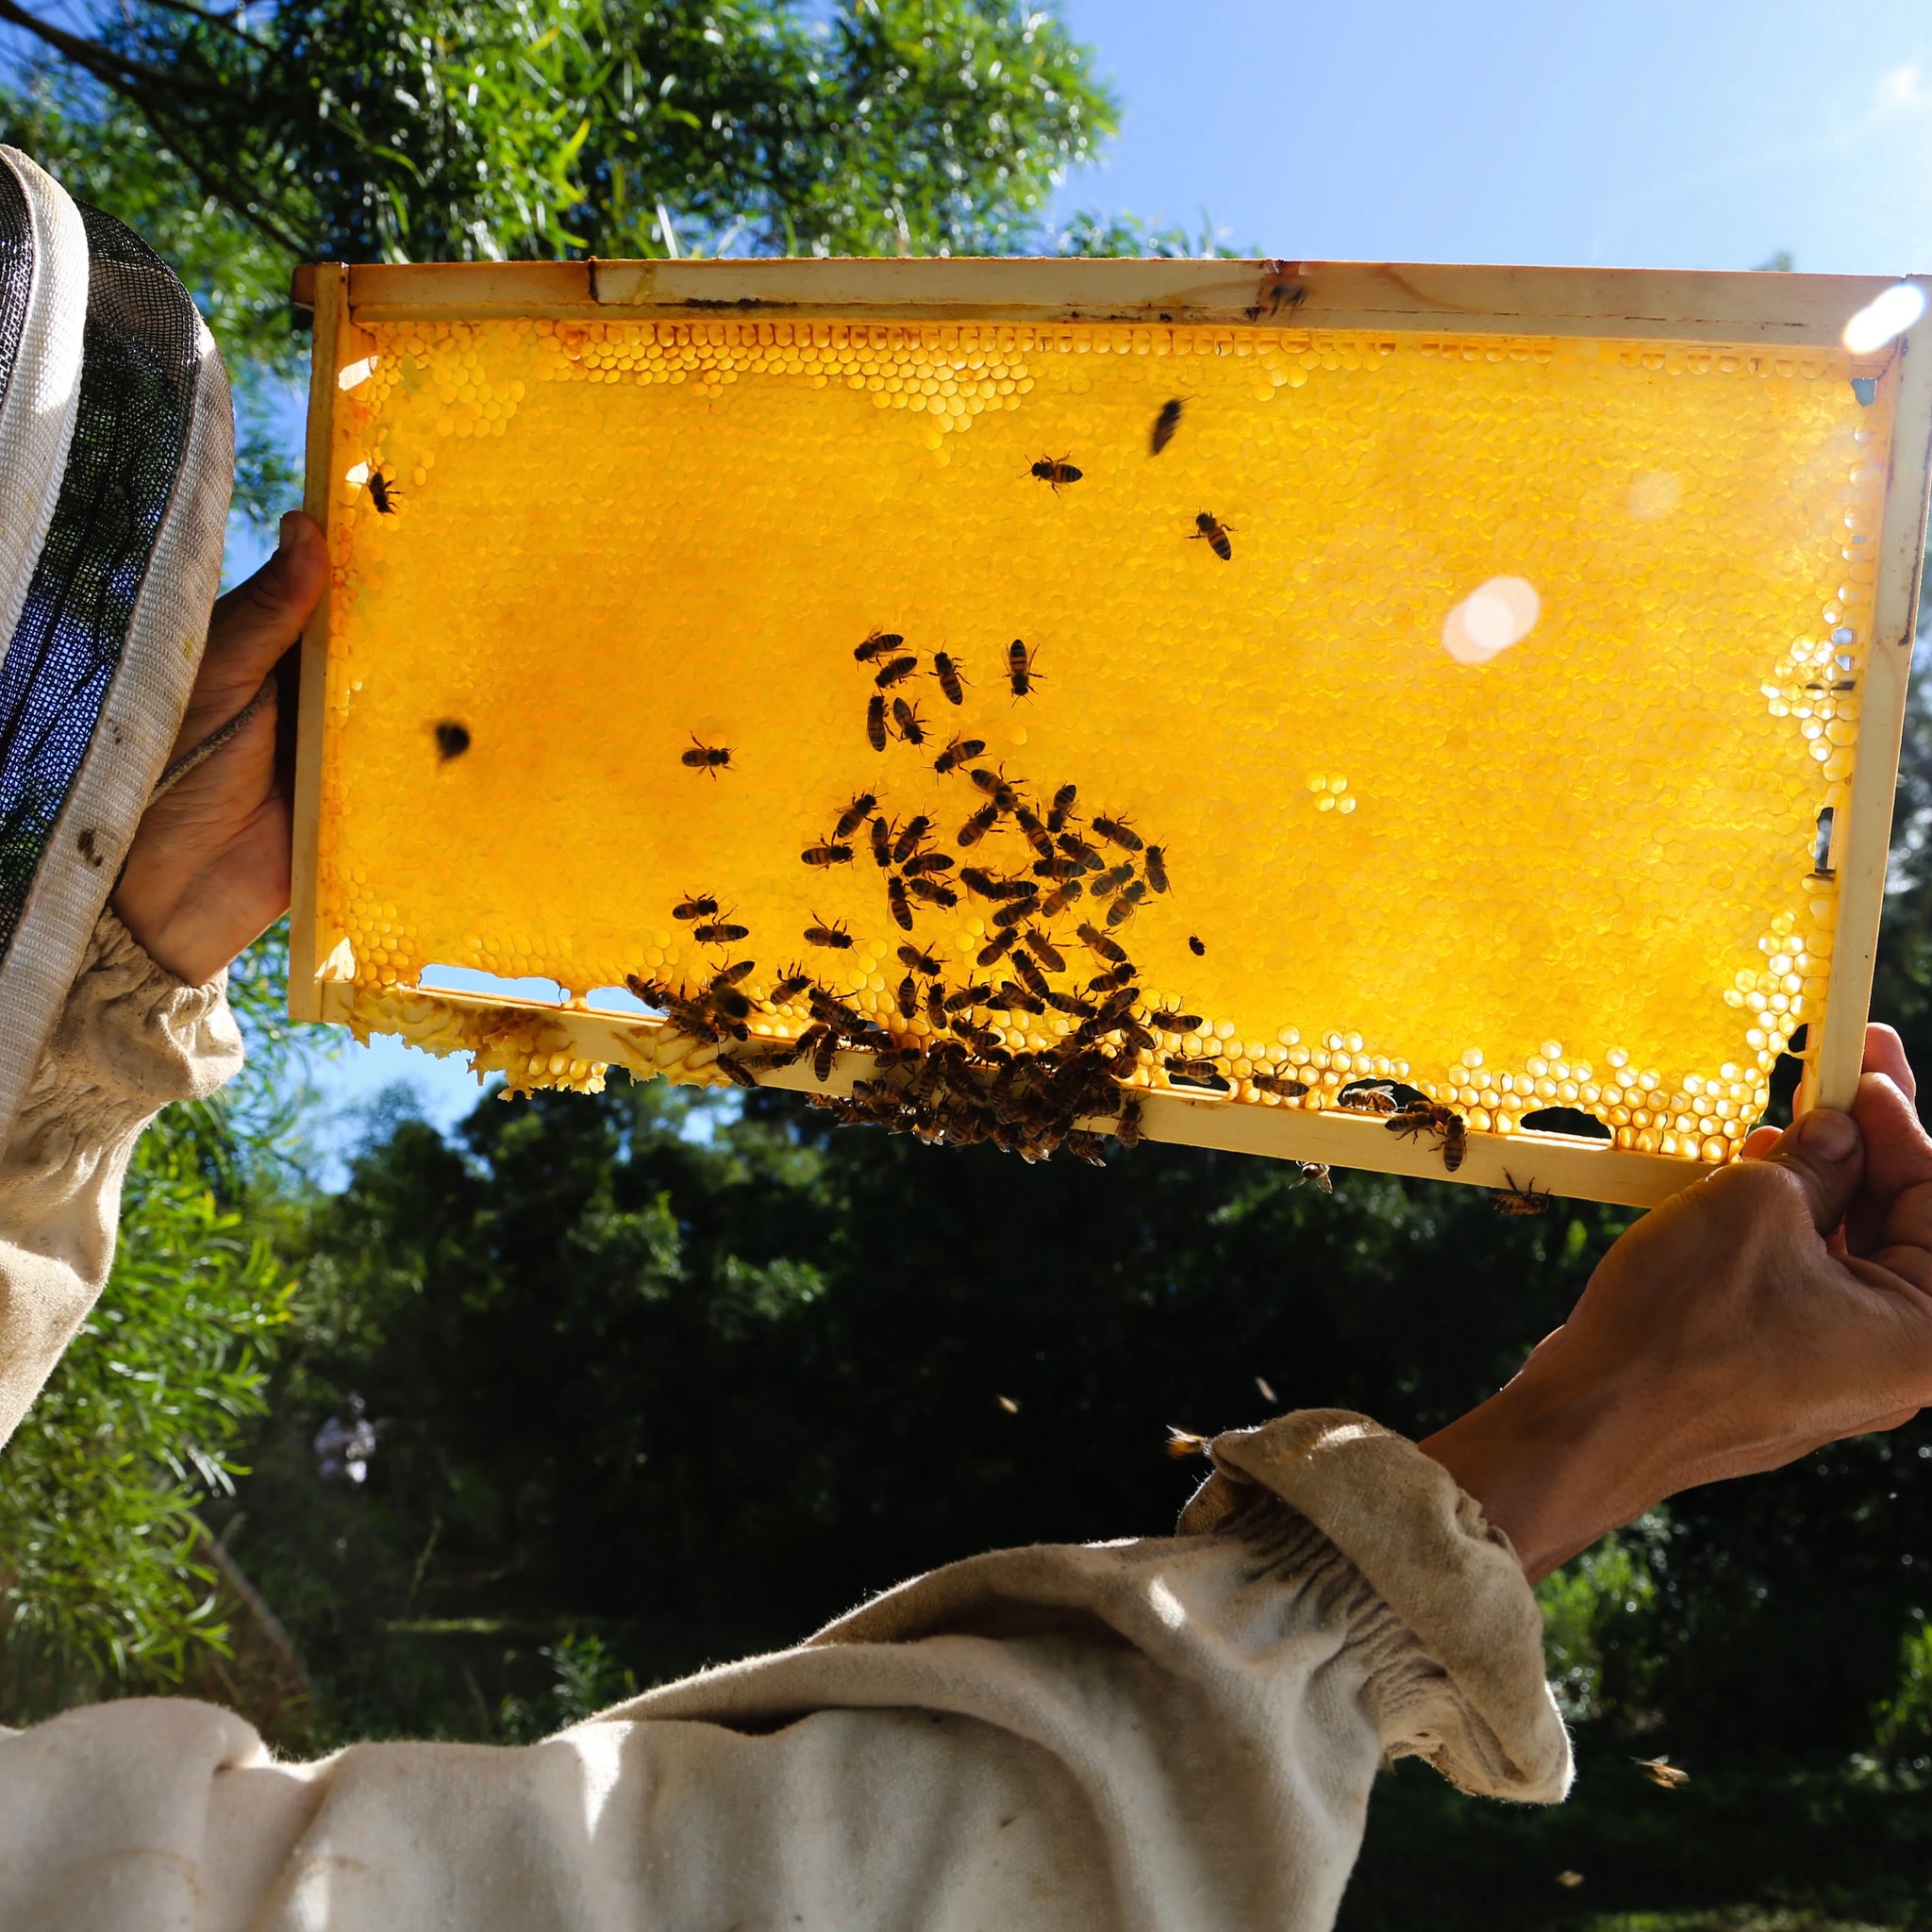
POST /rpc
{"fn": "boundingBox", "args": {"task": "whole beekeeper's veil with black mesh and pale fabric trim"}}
[0,147,234,1145]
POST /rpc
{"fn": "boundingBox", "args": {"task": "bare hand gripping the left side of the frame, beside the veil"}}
[114,510,328,985]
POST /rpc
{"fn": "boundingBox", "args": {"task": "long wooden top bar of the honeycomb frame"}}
[291,257,1916,351]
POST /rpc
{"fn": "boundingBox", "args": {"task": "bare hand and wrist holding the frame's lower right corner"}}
[1422,1025,1932,1580]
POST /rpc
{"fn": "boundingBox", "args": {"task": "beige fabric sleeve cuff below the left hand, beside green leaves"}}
[0,912,242,1443]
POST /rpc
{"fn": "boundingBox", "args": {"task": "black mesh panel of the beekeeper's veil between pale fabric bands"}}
[0,202,199,957]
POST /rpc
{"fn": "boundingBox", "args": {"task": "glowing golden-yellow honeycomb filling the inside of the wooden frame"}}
[317,319,1890,1161]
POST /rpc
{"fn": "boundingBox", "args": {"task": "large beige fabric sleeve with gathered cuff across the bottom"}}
[0,1412,1569,1932]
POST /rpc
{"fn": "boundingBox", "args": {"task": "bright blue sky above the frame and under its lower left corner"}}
[293,0,1932,1143]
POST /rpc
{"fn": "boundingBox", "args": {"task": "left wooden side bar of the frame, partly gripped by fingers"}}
[288,263,348,1020]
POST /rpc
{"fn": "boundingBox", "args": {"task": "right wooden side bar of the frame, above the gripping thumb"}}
[1807,278,1932,1108]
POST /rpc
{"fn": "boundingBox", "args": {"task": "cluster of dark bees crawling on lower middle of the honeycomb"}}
[630,400,1547,1213]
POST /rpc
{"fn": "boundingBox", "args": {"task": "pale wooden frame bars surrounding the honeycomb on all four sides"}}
[290,258,1932,1206]
